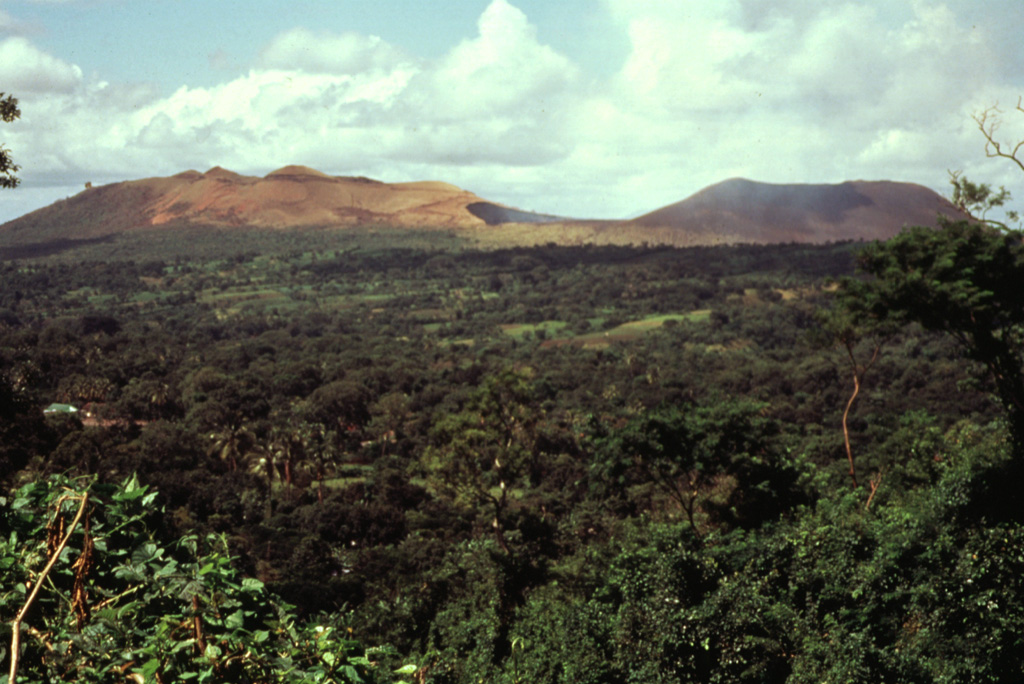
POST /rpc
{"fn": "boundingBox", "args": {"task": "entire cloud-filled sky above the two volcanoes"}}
[0,0,1024,221]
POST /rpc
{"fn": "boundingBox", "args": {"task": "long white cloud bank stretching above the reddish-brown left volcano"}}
[9,0,577,189]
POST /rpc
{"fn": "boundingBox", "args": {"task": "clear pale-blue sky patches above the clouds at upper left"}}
[18,0,629,94]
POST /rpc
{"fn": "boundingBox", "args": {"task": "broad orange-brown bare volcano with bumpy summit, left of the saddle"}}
[2,166,561,242]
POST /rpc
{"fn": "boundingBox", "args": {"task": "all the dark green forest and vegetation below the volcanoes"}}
[0,224,1024,684]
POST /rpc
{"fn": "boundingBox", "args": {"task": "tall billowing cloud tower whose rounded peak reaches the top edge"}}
[388,0,580,166]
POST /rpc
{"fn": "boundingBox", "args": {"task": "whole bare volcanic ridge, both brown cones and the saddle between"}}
[0,165,966,247]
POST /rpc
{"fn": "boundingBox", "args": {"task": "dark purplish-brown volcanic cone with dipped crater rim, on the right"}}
[630,178,966,244]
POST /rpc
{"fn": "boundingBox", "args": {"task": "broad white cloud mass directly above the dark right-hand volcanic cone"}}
[592,0,1019,214]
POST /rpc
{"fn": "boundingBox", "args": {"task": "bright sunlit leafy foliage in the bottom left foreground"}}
[0,477,387,682]
